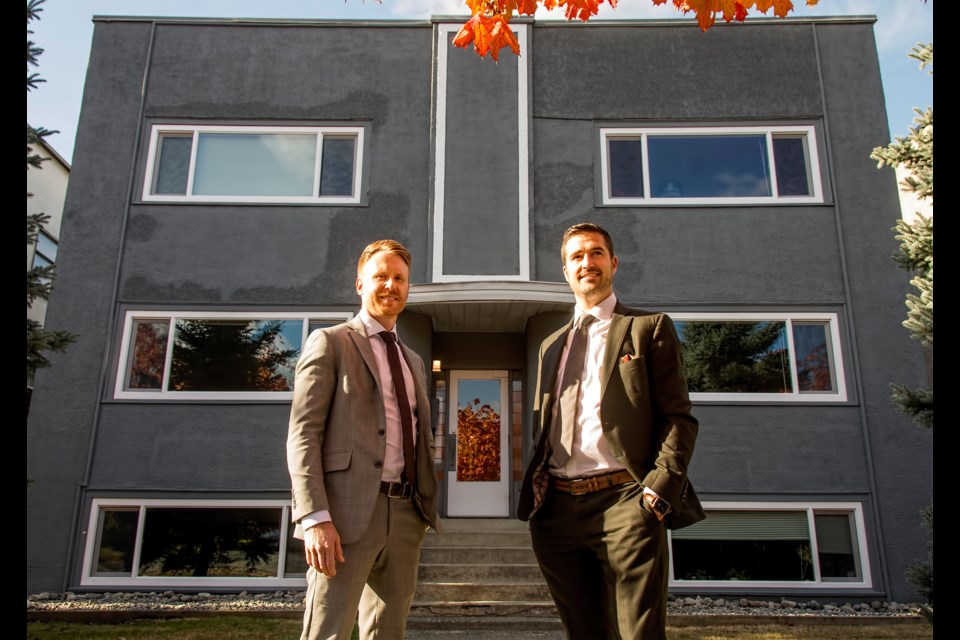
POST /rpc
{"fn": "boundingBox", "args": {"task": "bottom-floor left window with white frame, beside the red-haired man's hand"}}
[81,498,306,588]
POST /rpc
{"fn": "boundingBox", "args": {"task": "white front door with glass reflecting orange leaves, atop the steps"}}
[447,371,510,518]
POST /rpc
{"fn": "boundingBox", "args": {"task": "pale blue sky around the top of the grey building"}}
[27,0,934,162]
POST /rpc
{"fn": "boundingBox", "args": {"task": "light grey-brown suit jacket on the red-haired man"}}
[287,318,439,544]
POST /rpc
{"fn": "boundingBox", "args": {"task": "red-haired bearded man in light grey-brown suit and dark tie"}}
[287,240,438,640]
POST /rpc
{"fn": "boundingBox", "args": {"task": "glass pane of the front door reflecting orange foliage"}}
[457,380,500,482]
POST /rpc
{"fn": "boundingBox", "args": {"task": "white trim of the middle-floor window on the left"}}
[113,310,353,400]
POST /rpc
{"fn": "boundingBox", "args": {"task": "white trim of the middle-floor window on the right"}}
[668,312,847,403]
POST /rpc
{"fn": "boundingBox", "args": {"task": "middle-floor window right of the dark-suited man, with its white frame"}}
[670,313,847,402]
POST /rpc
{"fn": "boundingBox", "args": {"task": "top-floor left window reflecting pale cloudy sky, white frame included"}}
[143,125,364,204]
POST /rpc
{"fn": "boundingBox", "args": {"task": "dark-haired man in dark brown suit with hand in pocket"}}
[518,223,704,639]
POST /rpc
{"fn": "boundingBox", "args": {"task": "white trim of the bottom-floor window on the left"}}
[80,498,307,589]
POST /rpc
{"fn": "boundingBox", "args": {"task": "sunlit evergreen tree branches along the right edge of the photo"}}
[870,42,933,623]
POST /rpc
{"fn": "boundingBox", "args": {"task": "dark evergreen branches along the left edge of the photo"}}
[27,0,76,390]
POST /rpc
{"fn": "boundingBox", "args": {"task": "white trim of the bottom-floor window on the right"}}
[668,500,873,592]
